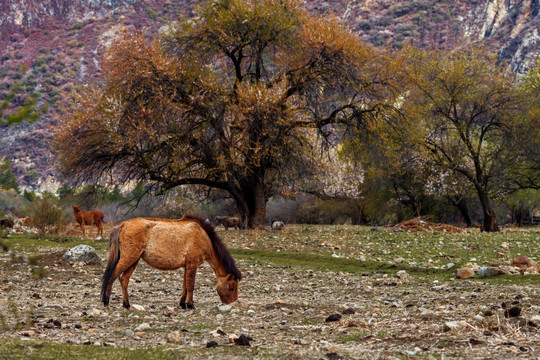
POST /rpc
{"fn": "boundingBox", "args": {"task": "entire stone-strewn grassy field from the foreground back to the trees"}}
[0,225,540,359]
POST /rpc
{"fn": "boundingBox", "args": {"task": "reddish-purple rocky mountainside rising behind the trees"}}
[0,0,540,190]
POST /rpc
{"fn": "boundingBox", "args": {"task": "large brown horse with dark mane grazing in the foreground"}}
[101,215,242,309]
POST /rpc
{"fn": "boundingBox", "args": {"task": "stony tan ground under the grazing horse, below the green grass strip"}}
[0,226,540,359]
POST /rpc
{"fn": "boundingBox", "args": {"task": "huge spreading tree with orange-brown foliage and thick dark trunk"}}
[57,0,392,227]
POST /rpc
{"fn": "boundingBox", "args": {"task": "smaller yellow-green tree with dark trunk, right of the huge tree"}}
[404,48,522,231]
